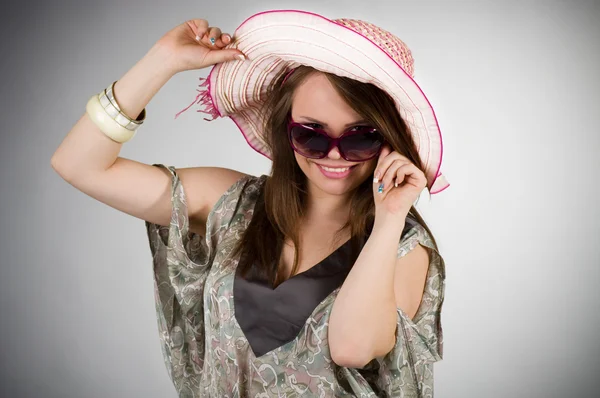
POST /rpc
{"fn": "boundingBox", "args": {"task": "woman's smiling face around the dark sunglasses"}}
[292,73,377,195]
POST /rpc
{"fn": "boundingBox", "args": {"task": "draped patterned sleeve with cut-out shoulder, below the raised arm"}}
[145,164,256,397]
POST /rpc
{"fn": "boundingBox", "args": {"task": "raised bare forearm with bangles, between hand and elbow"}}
[51,45,175,179]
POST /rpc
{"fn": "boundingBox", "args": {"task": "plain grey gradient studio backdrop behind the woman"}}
[0,0,600,398]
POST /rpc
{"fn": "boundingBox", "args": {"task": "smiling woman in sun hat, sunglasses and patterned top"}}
[52,10,448,397]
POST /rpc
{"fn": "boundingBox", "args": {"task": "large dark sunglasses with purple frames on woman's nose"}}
[287,119,385,162]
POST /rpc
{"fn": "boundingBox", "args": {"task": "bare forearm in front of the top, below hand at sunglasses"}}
[329,218,404,366]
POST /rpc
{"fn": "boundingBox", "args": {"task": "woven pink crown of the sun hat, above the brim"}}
[333,18,414,78]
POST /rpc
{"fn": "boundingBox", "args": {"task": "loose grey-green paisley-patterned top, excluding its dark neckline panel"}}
[146,164,445,398]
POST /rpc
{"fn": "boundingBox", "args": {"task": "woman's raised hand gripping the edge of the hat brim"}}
[156,19,244,73]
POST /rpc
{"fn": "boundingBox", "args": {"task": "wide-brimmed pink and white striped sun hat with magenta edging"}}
[175,10,450,194]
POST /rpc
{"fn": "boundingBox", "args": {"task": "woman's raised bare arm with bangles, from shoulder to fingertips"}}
[51,19,248,228]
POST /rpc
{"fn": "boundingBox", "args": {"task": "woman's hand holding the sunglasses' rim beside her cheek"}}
[373,145,427,221]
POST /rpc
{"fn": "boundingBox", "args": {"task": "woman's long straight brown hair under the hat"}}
[233,65,437,288]
